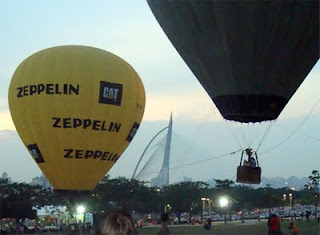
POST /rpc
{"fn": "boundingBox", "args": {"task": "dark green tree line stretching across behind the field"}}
[0,171,320,223]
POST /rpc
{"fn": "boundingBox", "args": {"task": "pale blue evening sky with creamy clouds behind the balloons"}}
[0,0,320,185]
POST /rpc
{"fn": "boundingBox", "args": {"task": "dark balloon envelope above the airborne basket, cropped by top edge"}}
[148,0,319,123]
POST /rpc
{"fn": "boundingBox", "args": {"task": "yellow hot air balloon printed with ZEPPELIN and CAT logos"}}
[9,46,145,190]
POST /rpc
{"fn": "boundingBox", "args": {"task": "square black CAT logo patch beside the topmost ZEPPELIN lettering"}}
[99,81,122,106]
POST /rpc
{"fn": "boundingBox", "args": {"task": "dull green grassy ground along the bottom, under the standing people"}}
[138,221,320,235]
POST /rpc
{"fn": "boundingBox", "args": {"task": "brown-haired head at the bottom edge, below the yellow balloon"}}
[100,213,134,235]
